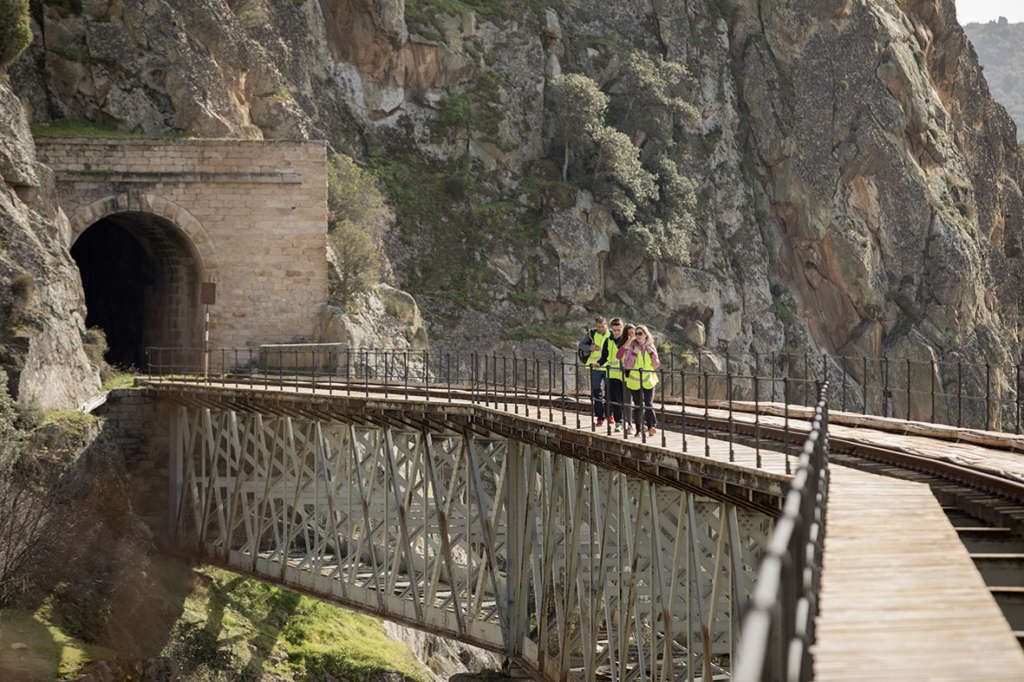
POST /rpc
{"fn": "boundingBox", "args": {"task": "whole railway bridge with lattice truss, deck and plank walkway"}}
[130,346,1024,682]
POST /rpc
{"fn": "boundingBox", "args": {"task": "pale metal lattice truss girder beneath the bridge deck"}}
[170,407,771,682]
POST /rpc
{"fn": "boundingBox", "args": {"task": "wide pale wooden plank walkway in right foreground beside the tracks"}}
[812,465,1024,682]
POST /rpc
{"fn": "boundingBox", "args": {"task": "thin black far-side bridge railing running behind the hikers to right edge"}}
[146,344,1024,450]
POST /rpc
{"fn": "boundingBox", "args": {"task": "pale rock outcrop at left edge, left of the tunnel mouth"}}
[0,79,99,410]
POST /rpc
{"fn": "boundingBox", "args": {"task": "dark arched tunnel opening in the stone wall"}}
[71,212,202,369]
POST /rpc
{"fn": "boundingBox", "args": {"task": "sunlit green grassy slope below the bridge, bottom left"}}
[0,557,431,682]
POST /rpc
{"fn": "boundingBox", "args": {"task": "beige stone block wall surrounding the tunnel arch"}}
[37,139,328,348]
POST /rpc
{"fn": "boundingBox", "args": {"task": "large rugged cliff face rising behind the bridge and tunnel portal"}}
[12,0,1024,413]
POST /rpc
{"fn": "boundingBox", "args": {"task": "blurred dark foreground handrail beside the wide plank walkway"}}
[732,384,828,682]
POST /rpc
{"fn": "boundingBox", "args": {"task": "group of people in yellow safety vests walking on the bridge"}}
[579,316,662,435]
